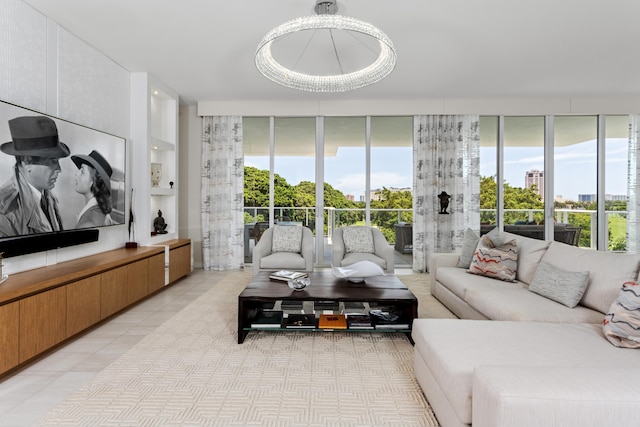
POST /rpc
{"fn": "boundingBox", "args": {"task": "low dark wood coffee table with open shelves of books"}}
[238,270,418,344]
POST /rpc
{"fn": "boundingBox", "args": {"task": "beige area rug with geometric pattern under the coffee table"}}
[39,271,453,427]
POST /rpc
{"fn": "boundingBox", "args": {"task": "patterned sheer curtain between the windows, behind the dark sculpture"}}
[413,115,480,272]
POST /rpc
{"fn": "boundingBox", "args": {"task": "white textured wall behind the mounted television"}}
[0,0,132,274]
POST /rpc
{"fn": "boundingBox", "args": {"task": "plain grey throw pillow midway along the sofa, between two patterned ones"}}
[529,261,589,308]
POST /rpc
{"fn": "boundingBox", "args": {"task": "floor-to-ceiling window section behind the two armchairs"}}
[243,117,413,267]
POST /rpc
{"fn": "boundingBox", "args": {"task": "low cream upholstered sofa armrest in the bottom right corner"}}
[472,365,640,427]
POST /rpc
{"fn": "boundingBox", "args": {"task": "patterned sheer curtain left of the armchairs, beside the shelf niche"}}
[201,116,244,271]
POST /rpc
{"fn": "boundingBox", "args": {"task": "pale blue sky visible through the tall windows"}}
[245,138,628,200]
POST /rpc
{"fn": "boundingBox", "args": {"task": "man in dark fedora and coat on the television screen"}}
[0,116,69,237]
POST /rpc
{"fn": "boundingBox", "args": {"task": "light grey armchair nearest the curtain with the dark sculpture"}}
[331,226,395,274]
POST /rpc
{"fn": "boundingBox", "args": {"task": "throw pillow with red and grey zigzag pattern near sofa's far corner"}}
[467,236,518,282]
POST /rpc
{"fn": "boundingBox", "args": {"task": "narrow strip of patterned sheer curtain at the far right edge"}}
[627,114,640,253]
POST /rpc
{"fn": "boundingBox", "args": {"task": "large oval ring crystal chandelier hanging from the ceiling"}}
[255,0,396,92]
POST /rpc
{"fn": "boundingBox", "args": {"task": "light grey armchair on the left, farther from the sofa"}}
[252,225,313,276]
